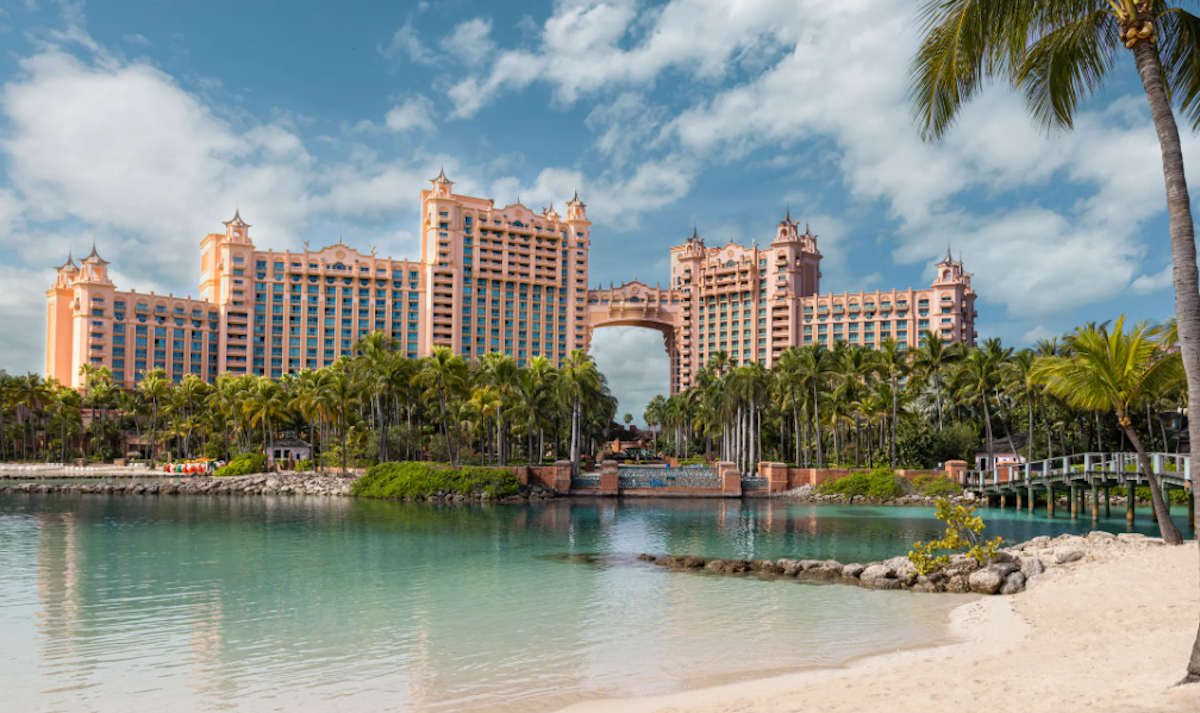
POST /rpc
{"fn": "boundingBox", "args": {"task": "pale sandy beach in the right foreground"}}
[566,543,1200,713]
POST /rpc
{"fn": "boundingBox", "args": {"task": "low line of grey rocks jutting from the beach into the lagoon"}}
[638,531,1163,594]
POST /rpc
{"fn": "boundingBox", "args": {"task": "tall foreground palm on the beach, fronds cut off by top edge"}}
[911,5,1200,683]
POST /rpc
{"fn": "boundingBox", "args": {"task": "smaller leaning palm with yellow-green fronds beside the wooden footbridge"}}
[1033,314,1183,545]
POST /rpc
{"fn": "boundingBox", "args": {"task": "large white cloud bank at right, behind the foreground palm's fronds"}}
[667,0,1195,316]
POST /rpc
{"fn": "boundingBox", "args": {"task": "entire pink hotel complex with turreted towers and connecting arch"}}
[46,173,977,394]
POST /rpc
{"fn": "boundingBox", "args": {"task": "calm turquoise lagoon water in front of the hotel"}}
[0,496,1180,713]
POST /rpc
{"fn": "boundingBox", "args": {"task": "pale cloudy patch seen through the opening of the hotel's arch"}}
[592,326,671,427]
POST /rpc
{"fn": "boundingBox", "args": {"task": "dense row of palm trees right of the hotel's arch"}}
[644,316,1187,473]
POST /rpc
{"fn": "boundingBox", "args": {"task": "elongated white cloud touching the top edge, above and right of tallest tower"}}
[449,0,800,118]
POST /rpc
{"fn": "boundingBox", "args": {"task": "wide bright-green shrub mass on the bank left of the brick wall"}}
[353,462,521,498]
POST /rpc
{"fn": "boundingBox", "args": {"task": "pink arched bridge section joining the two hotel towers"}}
[587,280,685,394]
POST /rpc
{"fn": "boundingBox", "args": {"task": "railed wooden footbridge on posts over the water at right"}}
[962,453,1196,527]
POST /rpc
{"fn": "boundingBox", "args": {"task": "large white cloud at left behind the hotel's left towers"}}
[0,42,456,367]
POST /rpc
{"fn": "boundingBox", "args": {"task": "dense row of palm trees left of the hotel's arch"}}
[0,332,617,477]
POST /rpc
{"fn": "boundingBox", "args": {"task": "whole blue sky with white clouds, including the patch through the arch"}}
[0,0,1200,423]
